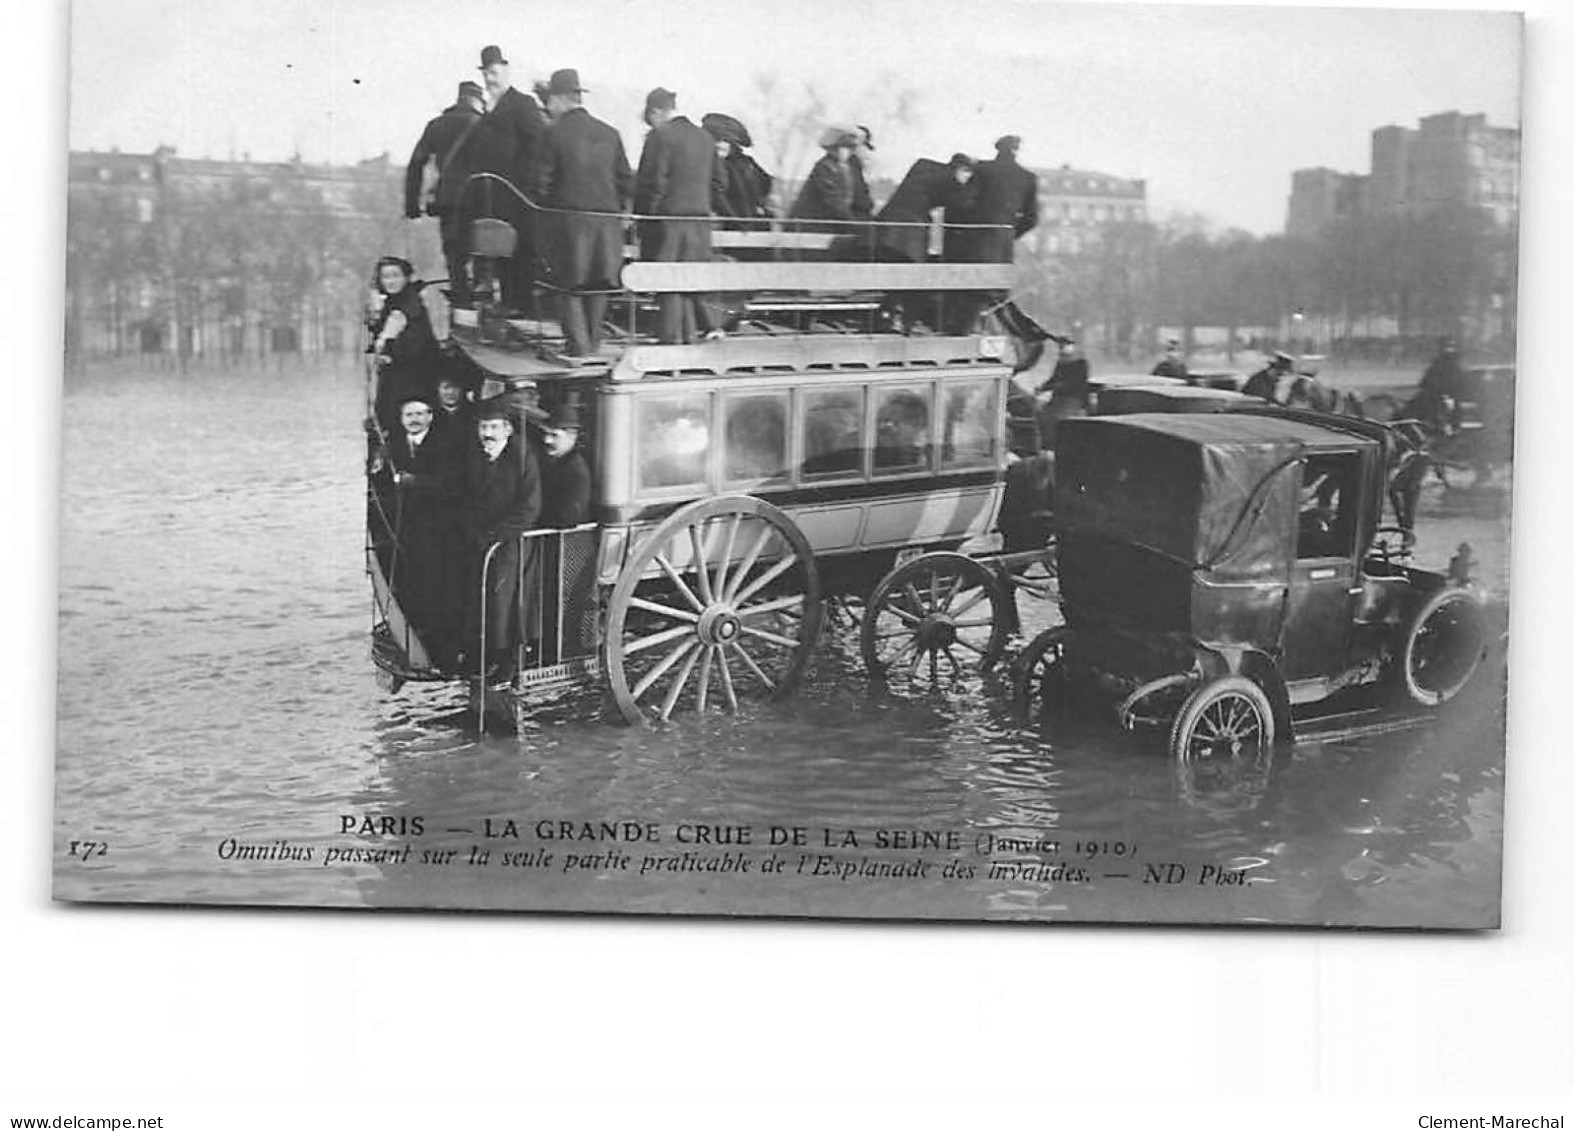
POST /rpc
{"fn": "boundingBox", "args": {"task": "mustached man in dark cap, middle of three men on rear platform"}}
[460,398,541,680]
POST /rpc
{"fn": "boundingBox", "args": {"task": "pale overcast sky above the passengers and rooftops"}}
[69,0,1520,233]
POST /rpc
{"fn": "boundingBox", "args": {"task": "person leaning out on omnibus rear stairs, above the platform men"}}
[367,255,442,436]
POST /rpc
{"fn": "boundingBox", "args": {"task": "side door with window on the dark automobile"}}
[1281,451,1362,682]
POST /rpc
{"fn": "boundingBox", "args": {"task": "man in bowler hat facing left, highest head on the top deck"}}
[480,46,546,315]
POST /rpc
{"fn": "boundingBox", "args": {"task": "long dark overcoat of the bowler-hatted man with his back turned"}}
[535,107,634,289]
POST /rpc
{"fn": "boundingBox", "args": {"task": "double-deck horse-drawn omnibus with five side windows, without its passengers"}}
[367,187,1034,722]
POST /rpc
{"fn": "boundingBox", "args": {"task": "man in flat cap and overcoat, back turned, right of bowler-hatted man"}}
[634,87,727,343]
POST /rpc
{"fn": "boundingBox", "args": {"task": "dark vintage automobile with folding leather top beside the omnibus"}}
[1014,406,1486,763]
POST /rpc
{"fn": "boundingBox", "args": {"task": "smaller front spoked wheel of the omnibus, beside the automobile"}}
[859,551,1011,684]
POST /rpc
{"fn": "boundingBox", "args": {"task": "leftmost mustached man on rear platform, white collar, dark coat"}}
[386,396,463,670]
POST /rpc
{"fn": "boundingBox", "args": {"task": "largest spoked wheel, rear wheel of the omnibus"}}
[606,496,820,724]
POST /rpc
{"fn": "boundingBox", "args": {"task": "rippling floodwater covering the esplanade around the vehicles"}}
[55,363,1508,927]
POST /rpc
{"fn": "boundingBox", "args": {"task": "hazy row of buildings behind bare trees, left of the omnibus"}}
[66,148,412,359]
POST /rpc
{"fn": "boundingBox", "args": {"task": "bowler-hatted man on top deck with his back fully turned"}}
[535,69,634,359]
